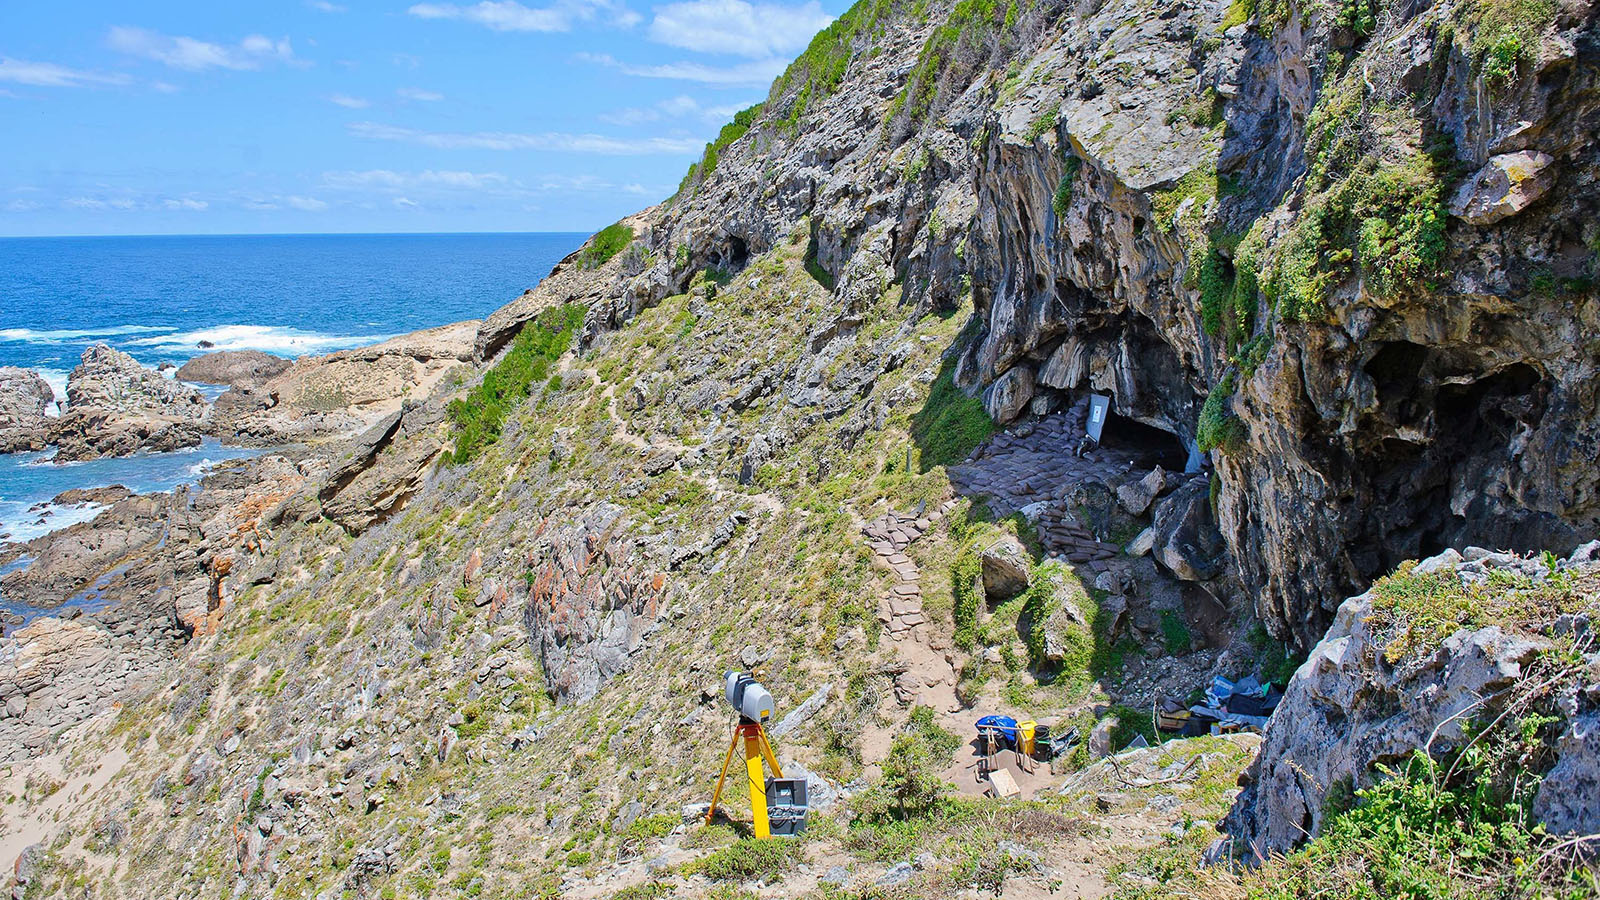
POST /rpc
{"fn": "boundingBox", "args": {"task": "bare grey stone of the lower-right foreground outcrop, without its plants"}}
[1224,551,1600,858]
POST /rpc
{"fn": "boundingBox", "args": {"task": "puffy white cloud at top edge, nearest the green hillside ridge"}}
[650,0,834,59]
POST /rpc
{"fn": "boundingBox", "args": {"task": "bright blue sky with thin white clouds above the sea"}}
[0,0,848,235]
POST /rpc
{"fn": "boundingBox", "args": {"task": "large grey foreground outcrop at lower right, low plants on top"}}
[1226,543,1600,860]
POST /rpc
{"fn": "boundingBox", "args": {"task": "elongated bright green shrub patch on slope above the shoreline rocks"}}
[448,303,584,463]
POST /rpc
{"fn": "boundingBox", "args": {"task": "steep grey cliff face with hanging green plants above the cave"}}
[530,2,1600,645]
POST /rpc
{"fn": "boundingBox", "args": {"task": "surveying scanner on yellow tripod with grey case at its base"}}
[706,673,806,838]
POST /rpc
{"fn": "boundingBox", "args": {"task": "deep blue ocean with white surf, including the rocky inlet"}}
[0,234,587,541]
